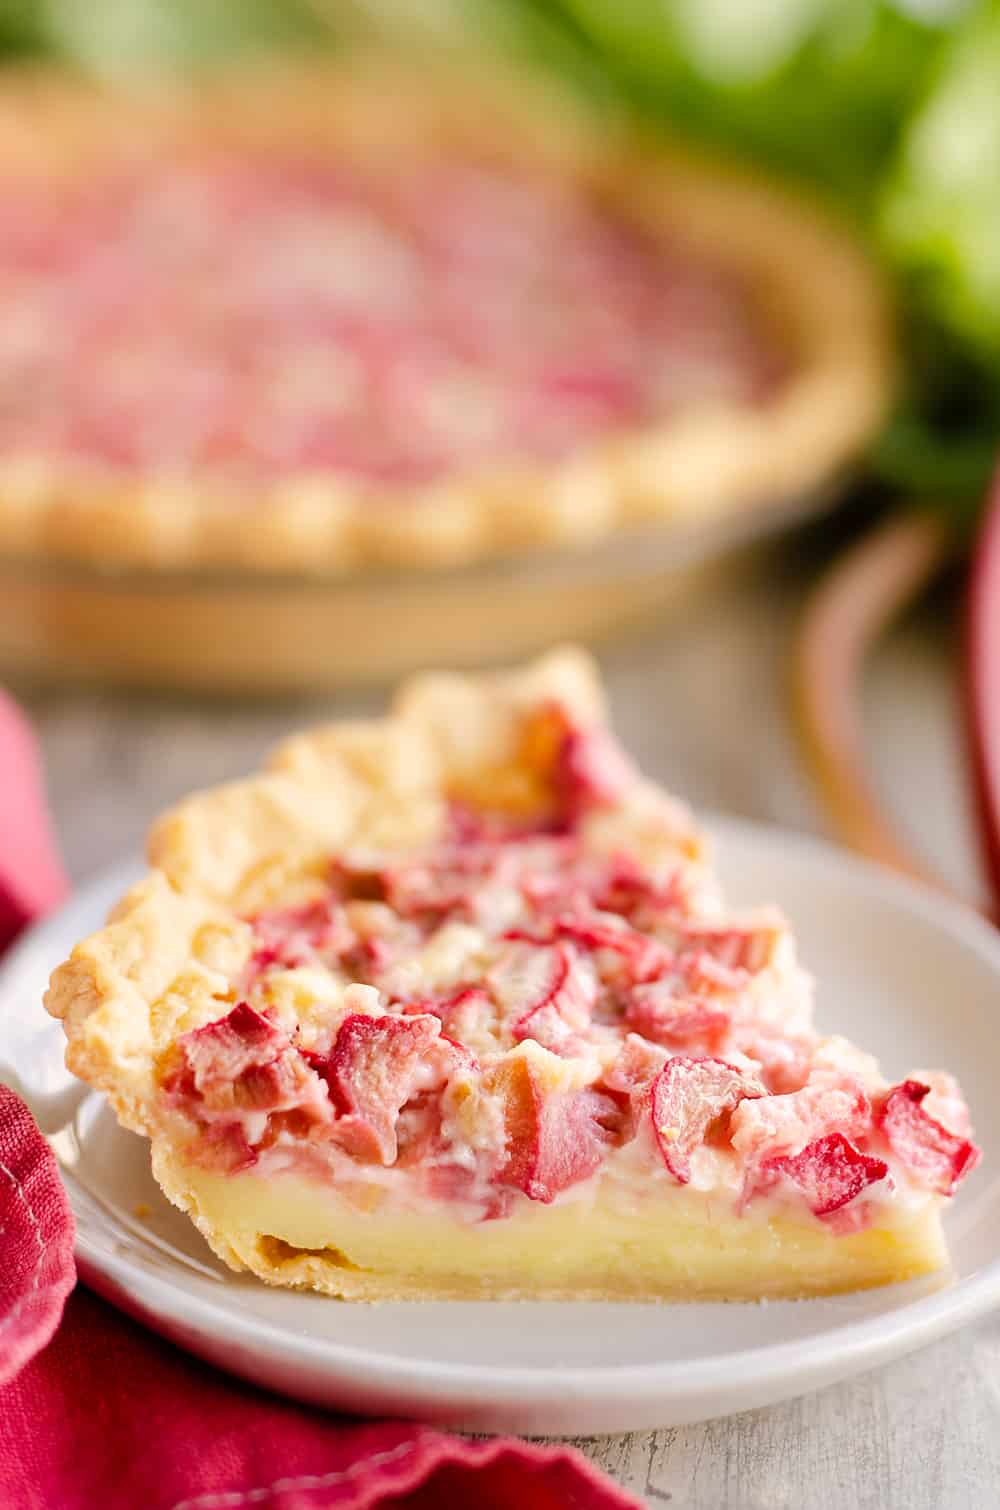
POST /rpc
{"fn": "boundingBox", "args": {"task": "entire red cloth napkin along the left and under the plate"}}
[0,695,639,1510]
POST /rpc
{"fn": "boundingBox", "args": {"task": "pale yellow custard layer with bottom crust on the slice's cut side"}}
[153,1148,947,1300]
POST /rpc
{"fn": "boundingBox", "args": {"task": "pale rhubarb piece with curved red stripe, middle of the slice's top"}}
[489,942,597,1052]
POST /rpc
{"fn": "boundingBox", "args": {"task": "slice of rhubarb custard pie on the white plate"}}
[45,651,977,1300]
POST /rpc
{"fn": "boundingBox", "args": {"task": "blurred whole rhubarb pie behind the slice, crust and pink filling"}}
[0,62,888,572]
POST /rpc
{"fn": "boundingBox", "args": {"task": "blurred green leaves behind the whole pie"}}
[0,0,1000,507]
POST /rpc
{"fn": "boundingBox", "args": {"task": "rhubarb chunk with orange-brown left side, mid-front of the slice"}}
[495,1059,621,1203]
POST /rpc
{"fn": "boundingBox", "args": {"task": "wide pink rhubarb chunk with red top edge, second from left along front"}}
[316,1013,441,1164]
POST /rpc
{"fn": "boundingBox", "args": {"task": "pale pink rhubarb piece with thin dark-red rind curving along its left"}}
[651,1055,767,1185]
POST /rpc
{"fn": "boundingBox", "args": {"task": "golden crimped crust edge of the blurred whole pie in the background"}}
[0,63,891,574]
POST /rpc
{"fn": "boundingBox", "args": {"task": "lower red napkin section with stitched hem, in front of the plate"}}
[0,1290,637,1510]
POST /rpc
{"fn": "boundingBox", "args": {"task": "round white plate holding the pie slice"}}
[0,821,1000,1435]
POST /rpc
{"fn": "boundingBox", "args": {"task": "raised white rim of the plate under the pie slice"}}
[7,809,1000,1409]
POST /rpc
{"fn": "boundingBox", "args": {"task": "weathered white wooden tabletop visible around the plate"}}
[15,551,1000,1510]
